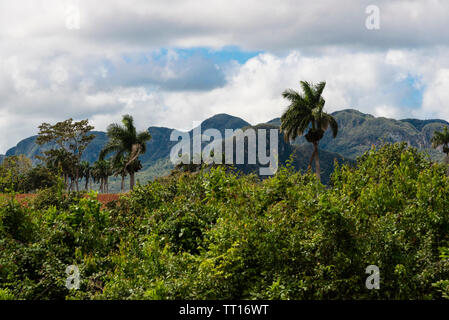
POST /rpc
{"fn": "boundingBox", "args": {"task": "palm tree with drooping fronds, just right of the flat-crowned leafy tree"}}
[100,115,151,190]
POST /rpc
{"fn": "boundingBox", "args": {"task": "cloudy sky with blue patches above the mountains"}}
[0,0,449,153]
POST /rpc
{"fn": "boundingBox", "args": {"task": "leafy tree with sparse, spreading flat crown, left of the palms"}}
[36,118,95,191]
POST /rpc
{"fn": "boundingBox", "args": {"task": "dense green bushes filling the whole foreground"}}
[0,144,449,299]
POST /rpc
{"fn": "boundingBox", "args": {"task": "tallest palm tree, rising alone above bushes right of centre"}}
[281,81,338,181]
